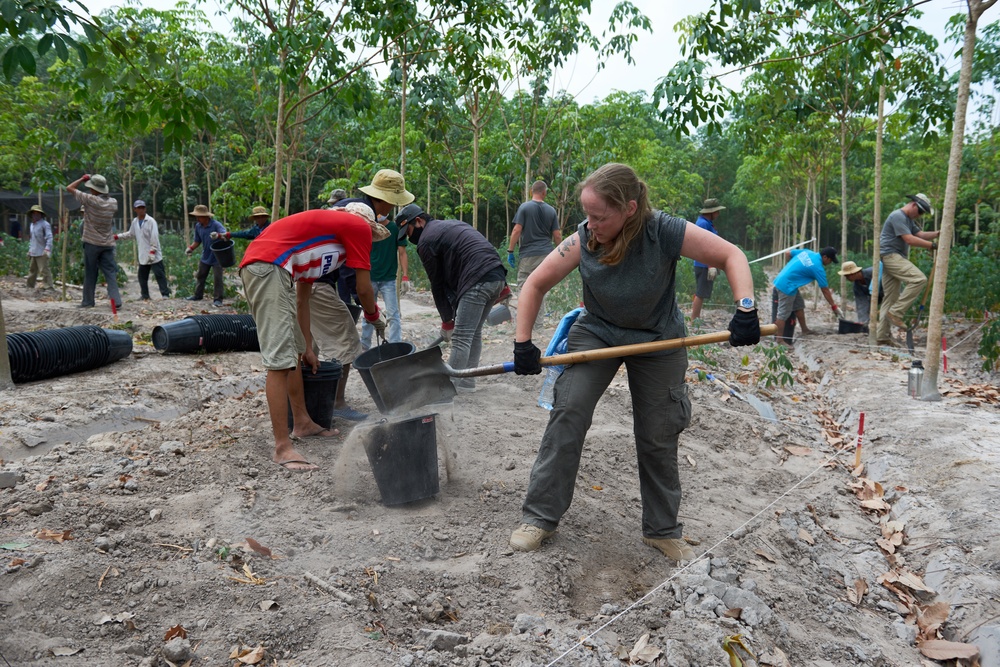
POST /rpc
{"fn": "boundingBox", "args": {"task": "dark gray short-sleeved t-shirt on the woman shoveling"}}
[577,211,690,354]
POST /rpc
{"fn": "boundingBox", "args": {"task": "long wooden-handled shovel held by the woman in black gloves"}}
[370,324,777,412]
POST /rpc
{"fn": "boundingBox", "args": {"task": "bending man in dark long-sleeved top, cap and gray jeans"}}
[396,204,507,392]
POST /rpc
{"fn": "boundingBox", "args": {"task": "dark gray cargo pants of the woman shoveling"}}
[521,326,691,539]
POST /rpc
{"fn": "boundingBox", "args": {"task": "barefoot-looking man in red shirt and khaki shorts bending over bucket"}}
[240,204,389,472]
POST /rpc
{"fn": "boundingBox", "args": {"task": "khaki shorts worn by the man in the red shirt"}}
[240,262,306,370]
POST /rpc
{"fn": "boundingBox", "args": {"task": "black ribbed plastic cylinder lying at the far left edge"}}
[7,325,132,382]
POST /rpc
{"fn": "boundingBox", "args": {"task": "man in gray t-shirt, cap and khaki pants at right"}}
[875,193,941,347]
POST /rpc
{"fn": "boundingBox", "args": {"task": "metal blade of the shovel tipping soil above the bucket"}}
[370,345,456,414]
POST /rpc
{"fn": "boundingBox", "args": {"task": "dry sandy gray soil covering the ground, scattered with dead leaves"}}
[0,278,1000,667]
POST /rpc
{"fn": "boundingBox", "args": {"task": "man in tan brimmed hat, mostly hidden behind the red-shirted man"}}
[309,169,413,421]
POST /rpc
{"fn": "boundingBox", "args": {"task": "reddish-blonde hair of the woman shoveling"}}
[577,162,653,266]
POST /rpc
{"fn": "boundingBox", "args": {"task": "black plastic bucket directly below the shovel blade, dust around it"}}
[365,414,440,505]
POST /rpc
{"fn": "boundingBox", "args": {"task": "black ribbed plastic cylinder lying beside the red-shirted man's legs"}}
[153,315,260,352]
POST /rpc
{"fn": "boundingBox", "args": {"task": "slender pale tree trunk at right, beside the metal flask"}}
[921,0,997,401]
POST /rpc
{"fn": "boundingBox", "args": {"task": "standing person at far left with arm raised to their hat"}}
[66,174,122,308]
